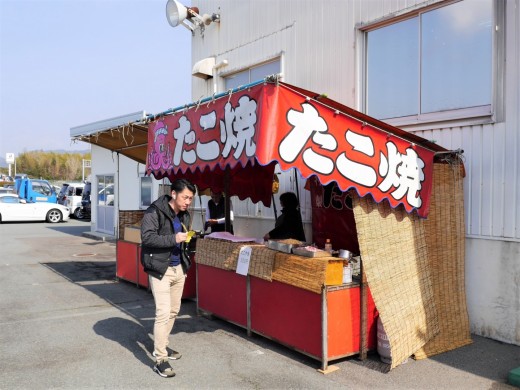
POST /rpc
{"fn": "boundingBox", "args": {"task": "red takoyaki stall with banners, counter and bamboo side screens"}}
[141,79,470,372]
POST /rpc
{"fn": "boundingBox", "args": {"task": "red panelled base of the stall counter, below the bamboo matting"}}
[197,264,377,371]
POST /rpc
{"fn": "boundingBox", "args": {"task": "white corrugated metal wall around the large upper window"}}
[192,0,520,345]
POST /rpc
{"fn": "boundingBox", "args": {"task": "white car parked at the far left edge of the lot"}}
[0,194,70,223]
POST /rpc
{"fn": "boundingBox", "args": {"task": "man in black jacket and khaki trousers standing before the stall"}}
[141,179,196,378]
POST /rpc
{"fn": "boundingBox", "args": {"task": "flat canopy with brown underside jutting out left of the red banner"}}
[70,111,148,164]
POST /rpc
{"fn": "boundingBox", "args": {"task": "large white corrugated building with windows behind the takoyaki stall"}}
[71,0,520,345]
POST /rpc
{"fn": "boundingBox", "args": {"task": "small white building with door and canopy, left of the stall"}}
[70,111,205,239]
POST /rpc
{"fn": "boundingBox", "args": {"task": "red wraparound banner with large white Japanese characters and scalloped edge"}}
[147,84,433,217]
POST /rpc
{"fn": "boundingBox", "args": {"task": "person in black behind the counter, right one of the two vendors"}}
[264,192,305,241]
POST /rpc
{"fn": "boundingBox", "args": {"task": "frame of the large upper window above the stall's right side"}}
[356,0,505,130]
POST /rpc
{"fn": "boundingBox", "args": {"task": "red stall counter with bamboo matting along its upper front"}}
[197,238,376,372]
